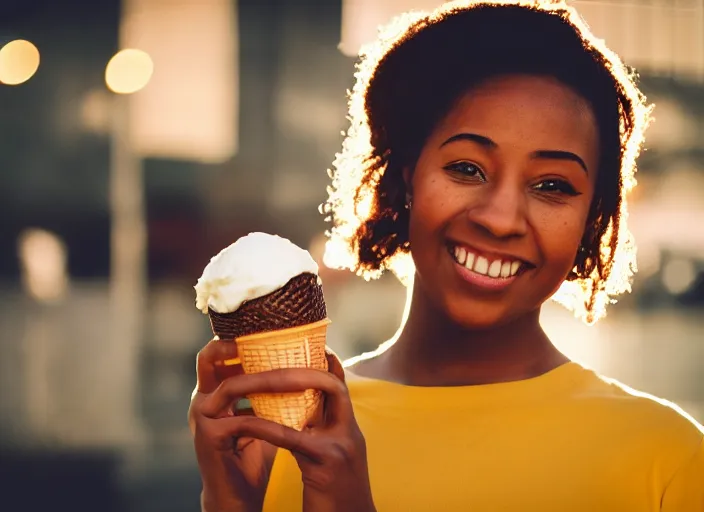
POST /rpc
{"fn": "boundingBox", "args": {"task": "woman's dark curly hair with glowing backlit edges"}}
[322,0,651,323]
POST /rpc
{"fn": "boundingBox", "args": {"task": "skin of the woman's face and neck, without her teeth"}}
[353,75,599,386]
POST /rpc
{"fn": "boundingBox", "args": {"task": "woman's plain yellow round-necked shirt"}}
[264,363,704,512]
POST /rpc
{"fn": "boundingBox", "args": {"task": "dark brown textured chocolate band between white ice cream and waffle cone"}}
[208,273,327,340]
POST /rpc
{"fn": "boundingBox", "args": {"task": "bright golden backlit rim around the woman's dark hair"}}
[321,0,652,324]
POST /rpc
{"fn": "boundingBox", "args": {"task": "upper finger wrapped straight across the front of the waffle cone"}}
[200,368,352,421]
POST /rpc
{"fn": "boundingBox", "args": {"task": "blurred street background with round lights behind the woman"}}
[0,0,704,512]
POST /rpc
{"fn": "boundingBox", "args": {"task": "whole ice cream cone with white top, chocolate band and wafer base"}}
[195,233,330,430]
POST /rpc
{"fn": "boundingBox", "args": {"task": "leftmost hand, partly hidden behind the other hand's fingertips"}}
[188,338,276,512]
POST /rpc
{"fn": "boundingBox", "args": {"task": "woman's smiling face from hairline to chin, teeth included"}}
[405,75,599,328]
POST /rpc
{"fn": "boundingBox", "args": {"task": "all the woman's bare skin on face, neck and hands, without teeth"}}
[189,76,599,512]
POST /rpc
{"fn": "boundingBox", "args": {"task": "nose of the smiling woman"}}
[467,181,528,238]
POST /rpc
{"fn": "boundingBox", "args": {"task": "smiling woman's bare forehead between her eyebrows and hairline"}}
[436,75,598,158]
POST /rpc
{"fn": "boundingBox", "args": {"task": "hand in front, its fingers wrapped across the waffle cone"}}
[195,356,376,512]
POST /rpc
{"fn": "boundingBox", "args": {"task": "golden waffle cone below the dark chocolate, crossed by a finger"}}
[235,318,330,430]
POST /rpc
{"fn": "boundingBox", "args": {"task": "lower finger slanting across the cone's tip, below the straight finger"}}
[206,416,325,461]
